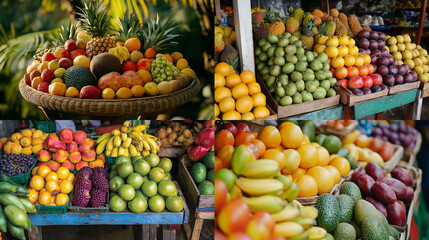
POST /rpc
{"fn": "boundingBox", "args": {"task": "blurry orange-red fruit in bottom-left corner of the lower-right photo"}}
[216,198,250,235]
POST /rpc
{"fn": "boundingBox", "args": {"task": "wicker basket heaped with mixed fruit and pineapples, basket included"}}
[20,2,199,116]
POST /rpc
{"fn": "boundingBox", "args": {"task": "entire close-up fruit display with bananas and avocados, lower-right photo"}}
[215,121,421,239]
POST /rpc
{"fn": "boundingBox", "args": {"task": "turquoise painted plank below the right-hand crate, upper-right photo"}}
[354,89,417,119]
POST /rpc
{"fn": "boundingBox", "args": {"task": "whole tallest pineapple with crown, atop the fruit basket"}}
[78,1,116,59]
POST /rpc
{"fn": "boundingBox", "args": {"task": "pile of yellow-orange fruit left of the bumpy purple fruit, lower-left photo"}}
[28,165,74,206]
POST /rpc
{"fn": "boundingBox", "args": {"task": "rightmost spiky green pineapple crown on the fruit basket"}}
[140,15,179,52]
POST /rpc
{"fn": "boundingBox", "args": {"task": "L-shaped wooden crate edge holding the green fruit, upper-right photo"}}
[256,74,340,118]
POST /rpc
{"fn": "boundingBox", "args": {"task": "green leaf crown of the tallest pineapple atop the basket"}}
[77,0,112,37]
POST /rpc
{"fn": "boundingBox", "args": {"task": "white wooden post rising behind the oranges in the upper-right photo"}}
[232,0,255,73]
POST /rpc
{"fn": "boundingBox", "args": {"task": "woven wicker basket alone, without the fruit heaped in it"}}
[19,79,201,117]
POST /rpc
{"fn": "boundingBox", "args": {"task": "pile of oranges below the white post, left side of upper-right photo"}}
[215,62,270,120]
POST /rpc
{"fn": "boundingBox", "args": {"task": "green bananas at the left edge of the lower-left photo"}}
[0,174,36,240]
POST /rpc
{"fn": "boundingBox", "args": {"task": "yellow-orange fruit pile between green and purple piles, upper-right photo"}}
[314,35,375,81]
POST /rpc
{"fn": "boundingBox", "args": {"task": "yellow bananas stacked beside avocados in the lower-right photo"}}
[231,159,327,240]
